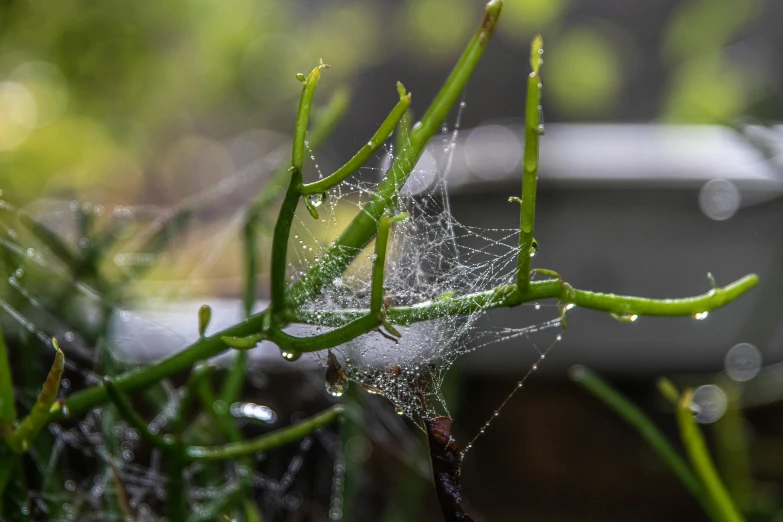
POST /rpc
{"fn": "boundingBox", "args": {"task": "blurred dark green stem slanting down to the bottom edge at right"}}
[569,366,714,518]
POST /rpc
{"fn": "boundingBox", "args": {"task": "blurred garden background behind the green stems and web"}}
[0,0,783,522]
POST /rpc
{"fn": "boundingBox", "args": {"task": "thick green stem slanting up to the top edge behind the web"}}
[286,0,503,309]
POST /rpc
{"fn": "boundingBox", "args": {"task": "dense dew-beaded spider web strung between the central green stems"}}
[291,97,561,432]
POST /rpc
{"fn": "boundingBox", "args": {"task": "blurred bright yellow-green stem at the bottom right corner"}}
[677,390,744,522]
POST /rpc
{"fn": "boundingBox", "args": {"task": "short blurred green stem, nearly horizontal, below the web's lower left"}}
[187,405,343,461]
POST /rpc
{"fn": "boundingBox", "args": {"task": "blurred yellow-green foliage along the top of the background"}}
[0,0,766,203]
